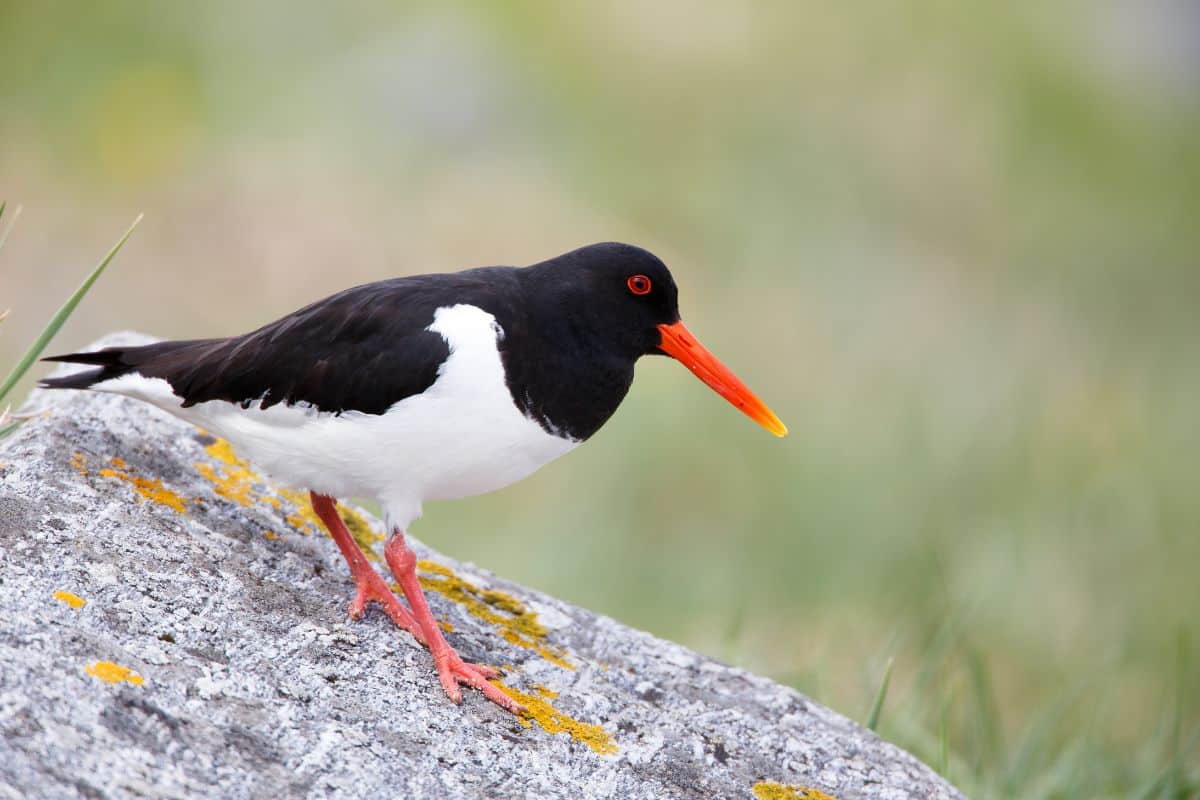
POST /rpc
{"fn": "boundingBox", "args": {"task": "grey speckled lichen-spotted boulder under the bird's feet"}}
[0,335,961,800]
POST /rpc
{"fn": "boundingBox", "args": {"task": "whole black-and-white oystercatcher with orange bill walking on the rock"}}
[41,242,787,711]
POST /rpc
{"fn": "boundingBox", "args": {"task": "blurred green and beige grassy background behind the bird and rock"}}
[0,0,1200,798]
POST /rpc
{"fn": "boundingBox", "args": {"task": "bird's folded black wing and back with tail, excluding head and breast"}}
[42,267,518,414]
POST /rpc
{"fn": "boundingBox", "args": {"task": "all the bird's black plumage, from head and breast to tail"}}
[42,243,678,439]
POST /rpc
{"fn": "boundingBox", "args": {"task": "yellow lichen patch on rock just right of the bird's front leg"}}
[416,561,575,669]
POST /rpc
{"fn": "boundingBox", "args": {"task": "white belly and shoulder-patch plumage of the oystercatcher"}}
[94,305,580,529]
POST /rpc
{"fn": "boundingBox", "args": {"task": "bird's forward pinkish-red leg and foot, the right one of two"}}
[383,530,523,714]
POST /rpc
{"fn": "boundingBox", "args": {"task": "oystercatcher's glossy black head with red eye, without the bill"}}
[523,242,679,360]
